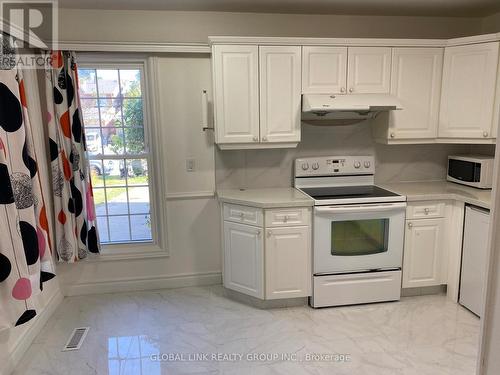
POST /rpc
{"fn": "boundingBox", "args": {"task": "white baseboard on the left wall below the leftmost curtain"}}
[0,290,64,375]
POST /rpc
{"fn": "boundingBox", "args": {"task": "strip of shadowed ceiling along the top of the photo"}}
[59,0,500,17]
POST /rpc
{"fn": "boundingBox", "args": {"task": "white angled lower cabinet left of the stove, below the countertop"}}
[222,203,312,299]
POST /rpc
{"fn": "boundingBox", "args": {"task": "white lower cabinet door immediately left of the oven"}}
[265,226,312,299]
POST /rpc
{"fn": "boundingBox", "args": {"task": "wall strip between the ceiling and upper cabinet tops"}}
[59,9,482,43]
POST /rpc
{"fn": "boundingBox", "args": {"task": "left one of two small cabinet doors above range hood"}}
[302,47,347,94]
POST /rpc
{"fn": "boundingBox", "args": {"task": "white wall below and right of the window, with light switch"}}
[58,54,221,295]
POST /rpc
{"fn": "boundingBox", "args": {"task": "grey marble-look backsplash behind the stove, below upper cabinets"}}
[215,121,492,189]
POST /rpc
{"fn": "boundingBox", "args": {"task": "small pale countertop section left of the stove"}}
[217,187,314,208]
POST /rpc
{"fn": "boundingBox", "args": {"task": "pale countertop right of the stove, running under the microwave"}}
[377,181,491,209]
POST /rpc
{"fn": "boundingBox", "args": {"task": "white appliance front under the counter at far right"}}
[459,206,490,317]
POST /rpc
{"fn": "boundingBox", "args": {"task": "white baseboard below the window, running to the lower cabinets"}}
[63,272,222,296]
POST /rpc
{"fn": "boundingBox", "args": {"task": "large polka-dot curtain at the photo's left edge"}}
[0,36,55,330]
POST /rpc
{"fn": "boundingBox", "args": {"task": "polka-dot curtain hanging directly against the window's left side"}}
[45,51,99,263]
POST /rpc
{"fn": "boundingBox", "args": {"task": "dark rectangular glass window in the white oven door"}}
[331,219,389,256]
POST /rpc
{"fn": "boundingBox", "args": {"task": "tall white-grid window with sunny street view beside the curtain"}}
[78,64,154,244]
